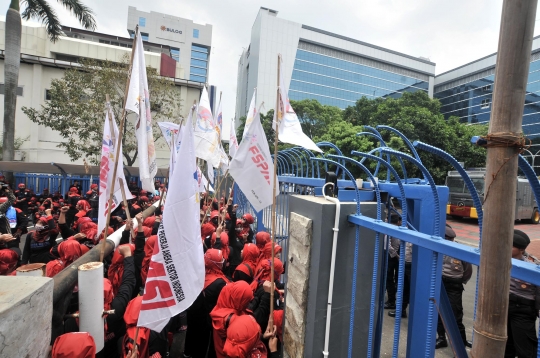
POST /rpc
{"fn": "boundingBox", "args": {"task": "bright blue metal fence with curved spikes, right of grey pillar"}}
[235,126,540,358]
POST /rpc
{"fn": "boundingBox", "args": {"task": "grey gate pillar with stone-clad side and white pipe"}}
[284,196,382,358]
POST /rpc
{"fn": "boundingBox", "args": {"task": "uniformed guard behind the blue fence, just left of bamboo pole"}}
[435,224,472,349]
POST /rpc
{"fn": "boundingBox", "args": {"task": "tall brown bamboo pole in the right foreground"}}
[471,0,537,358]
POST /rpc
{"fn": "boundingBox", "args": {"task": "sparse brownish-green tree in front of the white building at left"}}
[22,55,181,166]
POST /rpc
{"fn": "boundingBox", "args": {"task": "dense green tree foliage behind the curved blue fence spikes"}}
[237,91,487,184]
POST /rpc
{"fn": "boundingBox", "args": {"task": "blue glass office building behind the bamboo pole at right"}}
[434,37,540,138]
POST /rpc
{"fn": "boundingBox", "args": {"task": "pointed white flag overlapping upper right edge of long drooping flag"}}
[194,87,221,168]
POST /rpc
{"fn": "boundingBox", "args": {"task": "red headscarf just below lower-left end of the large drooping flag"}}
[122,296,150,357]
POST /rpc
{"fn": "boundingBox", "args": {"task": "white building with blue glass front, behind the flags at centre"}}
[235,7,435,125]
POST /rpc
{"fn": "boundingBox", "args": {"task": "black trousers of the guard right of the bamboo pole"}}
[504,302,538,358]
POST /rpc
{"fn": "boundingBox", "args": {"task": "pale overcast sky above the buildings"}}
[5,0,540,138]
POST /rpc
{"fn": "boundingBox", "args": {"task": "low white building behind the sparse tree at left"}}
[0,7,211,167]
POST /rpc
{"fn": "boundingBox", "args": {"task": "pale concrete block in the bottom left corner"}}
[0,276,54,358]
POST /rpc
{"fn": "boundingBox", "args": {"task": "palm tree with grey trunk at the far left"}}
[2,0,96,183]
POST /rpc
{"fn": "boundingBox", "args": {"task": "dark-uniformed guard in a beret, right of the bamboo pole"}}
[504,230,540,358]
